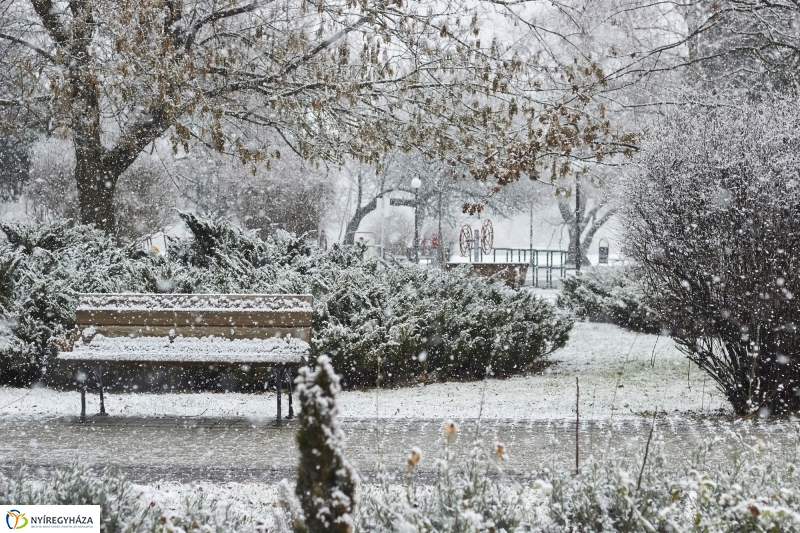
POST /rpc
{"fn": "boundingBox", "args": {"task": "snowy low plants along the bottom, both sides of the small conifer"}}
[6,418,800,533]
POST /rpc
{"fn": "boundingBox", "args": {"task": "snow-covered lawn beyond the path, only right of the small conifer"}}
[341,323,725,419]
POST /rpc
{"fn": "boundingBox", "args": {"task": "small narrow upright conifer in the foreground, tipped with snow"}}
[295,355,358,533]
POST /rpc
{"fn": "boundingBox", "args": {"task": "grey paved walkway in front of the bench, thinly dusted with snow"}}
[0,417,798,483]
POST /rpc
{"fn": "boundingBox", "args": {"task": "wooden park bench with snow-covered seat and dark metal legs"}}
[58,294,313,423]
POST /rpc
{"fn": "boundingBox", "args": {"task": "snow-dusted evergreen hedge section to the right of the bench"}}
[315,256,572,384]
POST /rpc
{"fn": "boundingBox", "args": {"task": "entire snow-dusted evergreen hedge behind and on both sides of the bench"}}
[0,214,572,389]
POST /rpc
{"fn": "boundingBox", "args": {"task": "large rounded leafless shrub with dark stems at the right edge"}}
[622,101,800,415]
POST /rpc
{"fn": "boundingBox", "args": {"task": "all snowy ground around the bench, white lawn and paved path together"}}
[0,316,800,519]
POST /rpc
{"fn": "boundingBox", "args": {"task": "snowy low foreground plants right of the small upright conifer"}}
[355,428,800,533]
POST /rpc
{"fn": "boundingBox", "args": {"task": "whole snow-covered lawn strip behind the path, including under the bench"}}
[0,323,727,419]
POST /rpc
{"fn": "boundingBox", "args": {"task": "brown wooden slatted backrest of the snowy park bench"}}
[76,293,313,342]
